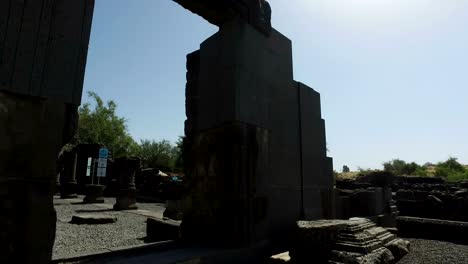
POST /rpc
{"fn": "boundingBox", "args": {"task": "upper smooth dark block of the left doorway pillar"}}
[0,0,94,105]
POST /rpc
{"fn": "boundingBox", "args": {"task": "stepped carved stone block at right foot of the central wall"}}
[290,218,409,263]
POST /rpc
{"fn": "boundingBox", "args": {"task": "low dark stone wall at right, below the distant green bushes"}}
[336,175,468,222]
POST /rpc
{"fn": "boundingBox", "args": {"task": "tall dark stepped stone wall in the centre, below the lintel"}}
[181,17,334,246]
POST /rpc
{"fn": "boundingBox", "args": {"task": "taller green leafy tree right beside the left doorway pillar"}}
[78,92,137,158]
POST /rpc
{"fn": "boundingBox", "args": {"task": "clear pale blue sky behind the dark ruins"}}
[82,0,468,171]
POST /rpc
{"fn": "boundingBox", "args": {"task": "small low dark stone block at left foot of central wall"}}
[146,218,181,241]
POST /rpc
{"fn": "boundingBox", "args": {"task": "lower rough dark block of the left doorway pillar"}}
[0,91,77,264]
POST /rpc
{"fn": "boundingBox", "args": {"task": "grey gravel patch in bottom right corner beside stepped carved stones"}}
[398,238,468,264]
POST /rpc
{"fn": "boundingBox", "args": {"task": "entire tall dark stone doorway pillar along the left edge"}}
[0,0,94,264]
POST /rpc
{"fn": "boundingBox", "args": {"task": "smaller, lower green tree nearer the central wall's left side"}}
[136,139,178,171]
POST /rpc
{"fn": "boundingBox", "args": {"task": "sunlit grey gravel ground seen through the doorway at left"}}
[53,197,164,259]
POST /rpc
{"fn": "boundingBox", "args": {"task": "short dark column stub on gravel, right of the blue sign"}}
[113,157,141,210]
